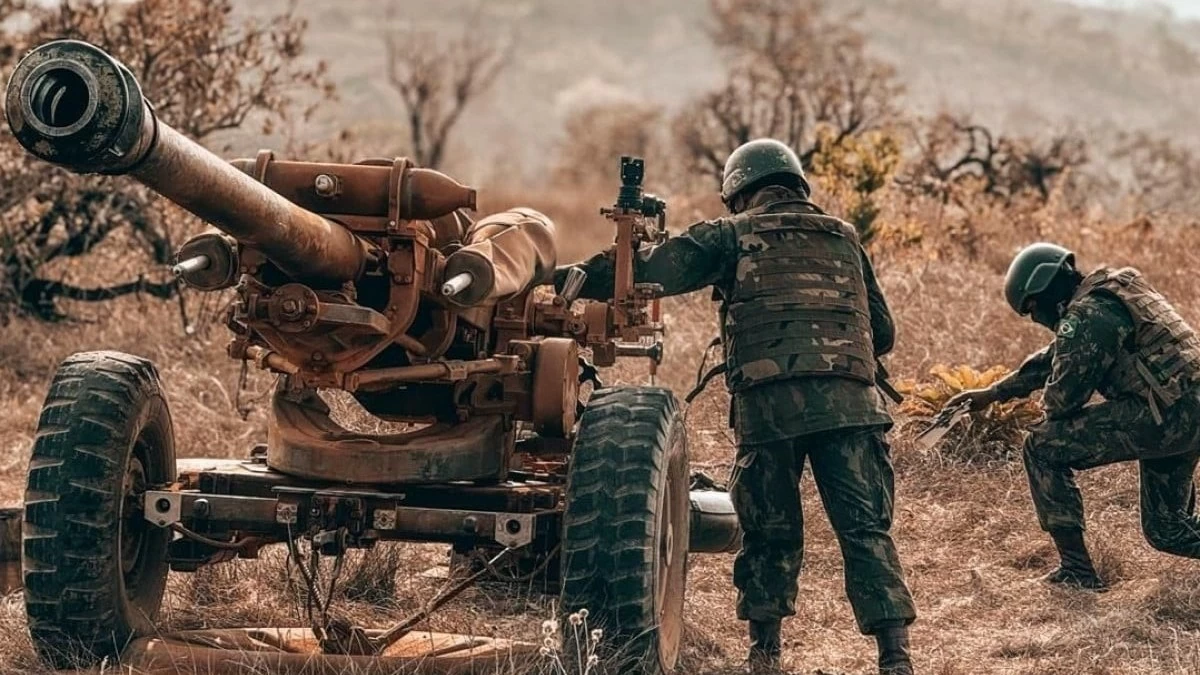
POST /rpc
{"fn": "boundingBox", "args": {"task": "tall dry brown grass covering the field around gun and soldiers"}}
[0,181,1200,675]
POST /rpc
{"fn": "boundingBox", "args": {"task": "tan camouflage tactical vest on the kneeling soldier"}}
[1072,268,1200,423]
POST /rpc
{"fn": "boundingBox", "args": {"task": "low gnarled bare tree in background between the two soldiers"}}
[896,113,1088,204]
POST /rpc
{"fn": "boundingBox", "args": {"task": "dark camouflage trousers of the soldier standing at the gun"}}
[730,428,917,633]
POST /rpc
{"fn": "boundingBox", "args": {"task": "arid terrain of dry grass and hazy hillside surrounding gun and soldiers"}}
[0,0,1200,675]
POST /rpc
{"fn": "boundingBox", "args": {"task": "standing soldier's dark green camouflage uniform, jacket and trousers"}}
[558,186,916,633]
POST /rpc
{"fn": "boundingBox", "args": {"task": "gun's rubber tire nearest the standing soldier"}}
[559,387,690,674]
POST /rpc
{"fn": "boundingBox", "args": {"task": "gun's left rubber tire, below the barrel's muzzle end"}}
[22,352,175,668]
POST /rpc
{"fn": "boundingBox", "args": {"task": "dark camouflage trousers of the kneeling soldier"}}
[1025,393,1200,557]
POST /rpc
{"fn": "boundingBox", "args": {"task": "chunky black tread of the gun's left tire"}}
[22,352,173,668]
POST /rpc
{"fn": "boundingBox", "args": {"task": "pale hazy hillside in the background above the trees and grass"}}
[235,0,1200,181]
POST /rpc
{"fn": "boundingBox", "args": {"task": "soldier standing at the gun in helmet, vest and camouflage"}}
[556,139,916,675]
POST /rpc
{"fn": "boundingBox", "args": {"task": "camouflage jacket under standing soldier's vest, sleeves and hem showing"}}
[556,187,895,444]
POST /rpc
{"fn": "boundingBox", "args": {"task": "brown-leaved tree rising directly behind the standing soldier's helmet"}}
[674,0,902,179]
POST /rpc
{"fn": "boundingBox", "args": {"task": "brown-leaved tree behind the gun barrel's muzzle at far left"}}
[0,0,331,318]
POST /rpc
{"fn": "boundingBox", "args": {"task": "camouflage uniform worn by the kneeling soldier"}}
[992,269,1200,557]
